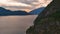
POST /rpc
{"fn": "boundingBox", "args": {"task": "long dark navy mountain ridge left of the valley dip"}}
[0,7,28,16]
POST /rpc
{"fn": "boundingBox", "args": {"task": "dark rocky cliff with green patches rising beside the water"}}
[26,0,60,34]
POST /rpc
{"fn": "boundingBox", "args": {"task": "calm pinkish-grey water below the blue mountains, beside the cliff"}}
[0,15,37,34]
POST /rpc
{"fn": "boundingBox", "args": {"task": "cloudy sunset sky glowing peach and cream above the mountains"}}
[0,0,52,12]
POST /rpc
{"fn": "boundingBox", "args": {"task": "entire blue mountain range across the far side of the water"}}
[0,7,44,16]
